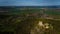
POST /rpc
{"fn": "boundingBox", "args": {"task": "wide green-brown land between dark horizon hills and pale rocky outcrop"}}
[0,8,60,34]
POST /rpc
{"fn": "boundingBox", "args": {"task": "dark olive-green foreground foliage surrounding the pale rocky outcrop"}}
[0,15,60,34]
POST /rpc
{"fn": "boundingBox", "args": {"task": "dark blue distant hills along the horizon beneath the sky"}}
[0,5,60,8]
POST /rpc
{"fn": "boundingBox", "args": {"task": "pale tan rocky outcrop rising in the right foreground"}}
[30,21,53,34]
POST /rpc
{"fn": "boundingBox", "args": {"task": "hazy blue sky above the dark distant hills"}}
[0,0,60,6]
